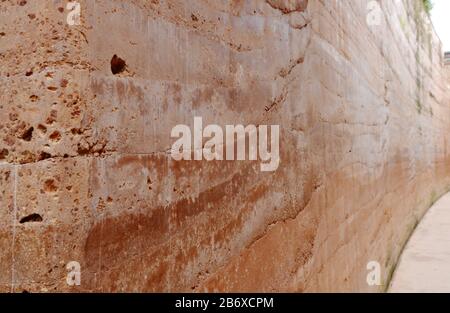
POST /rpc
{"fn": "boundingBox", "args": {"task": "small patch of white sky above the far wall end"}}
[431,0,450,51]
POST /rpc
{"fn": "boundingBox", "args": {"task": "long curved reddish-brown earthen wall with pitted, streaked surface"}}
[0,0,450,292]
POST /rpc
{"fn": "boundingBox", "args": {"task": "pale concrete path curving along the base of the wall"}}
[389,193,450,292]
